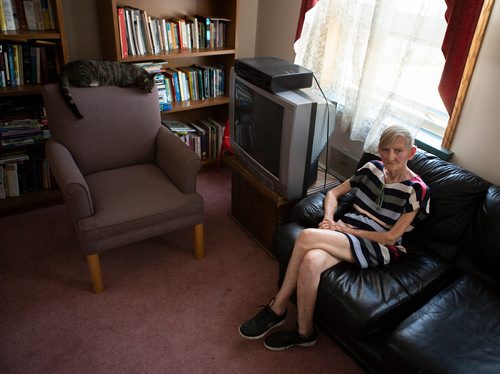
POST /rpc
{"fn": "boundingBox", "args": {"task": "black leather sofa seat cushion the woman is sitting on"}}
[316,244,455,339]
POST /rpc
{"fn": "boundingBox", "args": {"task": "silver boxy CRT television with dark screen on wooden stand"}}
[229,70,336,200]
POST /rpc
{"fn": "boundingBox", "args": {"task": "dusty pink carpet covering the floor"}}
[0,169,362,374]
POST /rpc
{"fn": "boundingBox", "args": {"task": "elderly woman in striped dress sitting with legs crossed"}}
[239,126,429,350]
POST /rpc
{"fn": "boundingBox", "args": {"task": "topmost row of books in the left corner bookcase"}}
[0,0,57,31]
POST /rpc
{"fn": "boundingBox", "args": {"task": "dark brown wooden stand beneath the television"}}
[224,156,293,251]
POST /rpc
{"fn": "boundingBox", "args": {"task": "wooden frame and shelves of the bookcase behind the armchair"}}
[97,0,238,168]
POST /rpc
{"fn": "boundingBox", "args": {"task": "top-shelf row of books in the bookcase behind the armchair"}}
[117,7,230,58]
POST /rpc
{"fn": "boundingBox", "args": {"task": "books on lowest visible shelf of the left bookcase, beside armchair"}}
[0,150,52,199]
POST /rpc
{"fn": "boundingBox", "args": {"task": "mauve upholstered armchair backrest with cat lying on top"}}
[42,84,161,175]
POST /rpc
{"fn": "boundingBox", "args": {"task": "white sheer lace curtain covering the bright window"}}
[295,0,446,153]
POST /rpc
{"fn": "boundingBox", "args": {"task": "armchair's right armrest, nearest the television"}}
[156,126,201,193]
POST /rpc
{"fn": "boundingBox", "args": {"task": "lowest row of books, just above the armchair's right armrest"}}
[162,117,224,161]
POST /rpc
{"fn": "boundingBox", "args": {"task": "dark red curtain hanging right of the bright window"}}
[439,0,484,115]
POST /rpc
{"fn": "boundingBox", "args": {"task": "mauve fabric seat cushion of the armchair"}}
[77,164,203,252]
